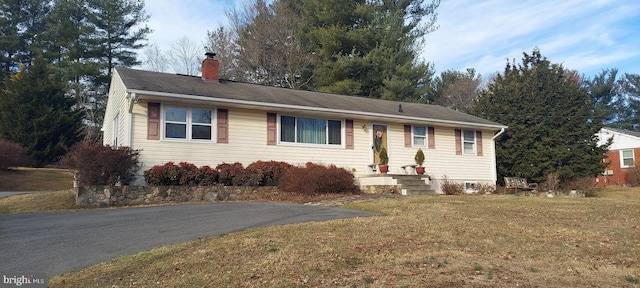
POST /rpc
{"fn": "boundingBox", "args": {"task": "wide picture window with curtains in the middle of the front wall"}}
[280,116,342,145]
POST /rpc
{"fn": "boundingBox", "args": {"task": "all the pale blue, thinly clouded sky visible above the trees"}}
[145,0,640,77]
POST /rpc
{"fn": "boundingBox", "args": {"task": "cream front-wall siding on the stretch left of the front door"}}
[133,103,370,174]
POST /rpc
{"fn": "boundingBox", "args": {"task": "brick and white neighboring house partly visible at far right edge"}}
[596,127,640,187]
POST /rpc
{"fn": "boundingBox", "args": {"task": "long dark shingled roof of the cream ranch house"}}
[116,67,506,129]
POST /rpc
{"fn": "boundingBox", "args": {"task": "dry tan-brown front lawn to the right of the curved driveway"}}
[49,188,640,287]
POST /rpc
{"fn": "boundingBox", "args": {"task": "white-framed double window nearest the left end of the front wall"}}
[164,106,213,140]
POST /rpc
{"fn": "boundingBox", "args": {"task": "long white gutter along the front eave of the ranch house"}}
[127,90,506,131]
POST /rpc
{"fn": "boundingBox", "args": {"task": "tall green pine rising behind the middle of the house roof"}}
[298,0,439,101]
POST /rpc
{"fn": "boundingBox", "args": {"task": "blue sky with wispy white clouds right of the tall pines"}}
[423,0,640,76]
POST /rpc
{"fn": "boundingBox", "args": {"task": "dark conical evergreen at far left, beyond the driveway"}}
[0,56,82,167]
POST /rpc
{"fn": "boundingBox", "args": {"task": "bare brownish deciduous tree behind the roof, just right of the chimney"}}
[220,0,314,89]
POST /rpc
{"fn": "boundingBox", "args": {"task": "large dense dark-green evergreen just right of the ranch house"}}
[474,50,607,183]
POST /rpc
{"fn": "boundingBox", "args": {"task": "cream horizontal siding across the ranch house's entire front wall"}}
[125,102,495,188]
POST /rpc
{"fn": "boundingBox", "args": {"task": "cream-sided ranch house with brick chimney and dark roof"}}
[103,54,506,190]
